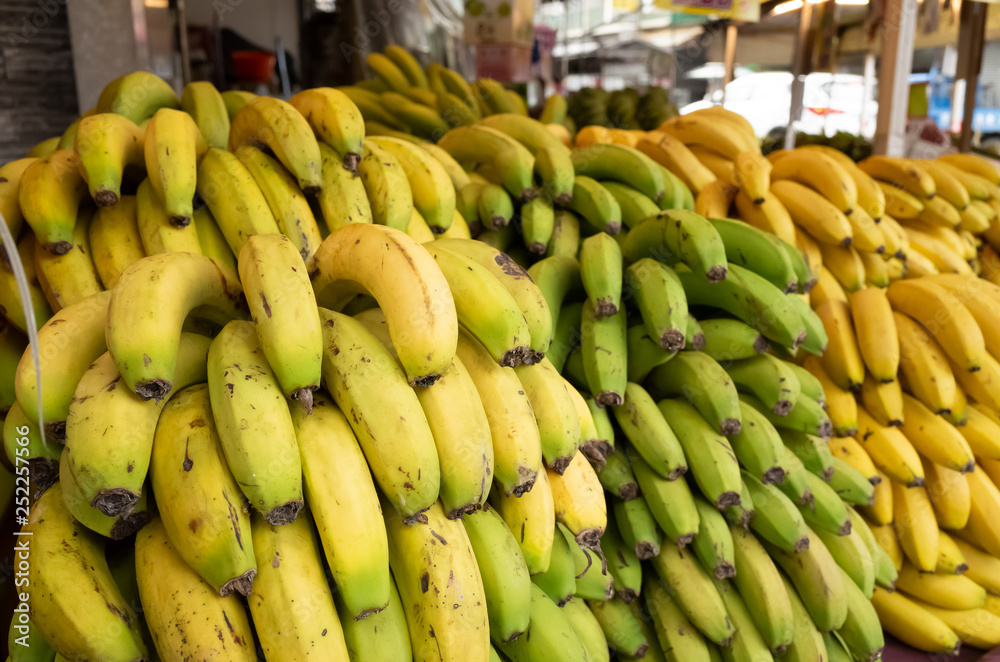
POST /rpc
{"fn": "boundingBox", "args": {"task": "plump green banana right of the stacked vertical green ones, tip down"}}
[624,258,688,352]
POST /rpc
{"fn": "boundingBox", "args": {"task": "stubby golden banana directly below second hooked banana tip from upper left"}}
[89,195,146,290]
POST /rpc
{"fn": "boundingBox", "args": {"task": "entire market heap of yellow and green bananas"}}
[0,47,1000,662]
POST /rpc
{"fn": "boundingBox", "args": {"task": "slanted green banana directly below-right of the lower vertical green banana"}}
[614,382,688,480]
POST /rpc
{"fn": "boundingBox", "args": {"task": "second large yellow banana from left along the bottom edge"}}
[135,519,257,662]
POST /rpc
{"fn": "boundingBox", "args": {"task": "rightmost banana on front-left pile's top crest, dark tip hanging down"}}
[288,87,365,172]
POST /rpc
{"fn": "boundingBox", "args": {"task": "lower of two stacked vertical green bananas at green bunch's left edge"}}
[580,299,628,407]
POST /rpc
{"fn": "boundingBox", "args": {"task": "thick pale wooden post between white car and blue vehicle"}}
[872,0,917,156]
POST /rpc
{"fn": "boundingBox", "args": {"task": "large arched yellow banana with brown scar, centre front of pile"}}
[310,223,458,386]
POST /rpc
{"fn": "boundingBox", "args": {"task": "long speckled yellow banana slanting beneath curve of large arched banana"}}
[320,310,443,524]
